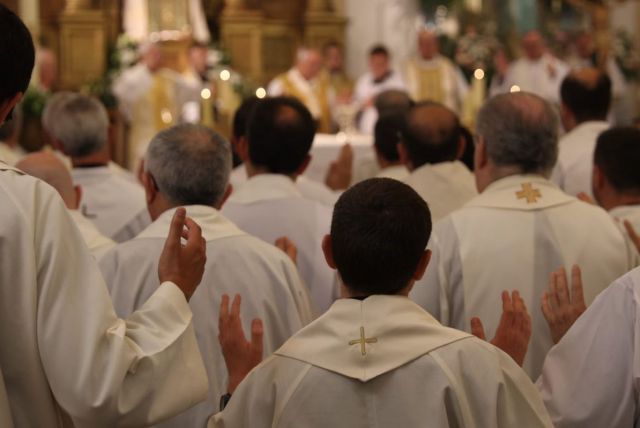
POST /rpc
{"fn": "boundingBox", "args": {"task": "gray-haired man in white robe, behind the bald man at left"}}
[53,95,151,242]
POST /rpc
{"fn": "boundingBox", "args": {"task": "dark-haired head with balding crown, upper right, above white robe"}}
[560,68,612,125]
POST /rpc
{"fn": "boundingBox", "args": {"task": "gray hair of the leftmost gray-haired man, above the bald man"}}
[52,94,109,158]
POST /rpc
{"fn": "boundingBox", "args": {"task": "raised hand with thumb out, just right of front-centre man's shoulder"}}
[471,291,531,366]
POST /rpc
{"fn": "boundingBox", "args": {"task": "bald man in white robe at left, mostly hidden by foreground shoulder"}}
[16,152,116,260]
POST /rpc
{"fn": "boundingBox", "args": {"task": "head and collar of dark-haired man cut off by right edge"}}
[593,127,640,239]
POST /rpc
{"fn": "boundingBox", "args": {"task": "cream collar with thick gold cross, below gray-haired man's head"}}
[465,174,577,211]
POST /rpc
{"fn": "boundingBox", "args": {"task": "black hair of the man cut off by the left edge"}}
[0,4,35,102]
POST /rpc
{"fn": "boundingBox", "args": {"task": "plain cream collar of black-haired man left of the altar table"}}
[229,174,302,204]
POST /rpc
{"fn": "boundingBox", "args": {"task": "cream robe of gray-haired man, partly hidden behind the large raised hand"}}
[100,205,313,428]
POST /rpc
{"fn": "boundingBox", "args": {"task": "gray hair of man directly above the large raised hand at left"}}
[145,123,231,205]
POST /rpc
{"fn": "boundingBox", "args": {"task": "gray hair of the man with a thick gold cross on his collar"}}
[477,92,560,176]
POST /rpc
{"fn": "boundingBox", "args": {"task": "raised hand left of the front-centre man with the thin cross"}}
[218,294,264,394]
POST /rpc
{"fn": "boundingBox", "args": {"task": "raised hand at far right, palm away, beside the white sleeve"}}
[541,266,587,343]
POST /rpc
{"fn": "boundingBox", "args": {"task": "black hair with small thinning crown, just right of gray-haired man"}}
[248,97,316,175]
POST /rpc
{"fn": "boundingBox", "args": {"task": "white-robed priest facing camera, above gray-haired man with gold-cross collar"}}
[490,31,569,105]
